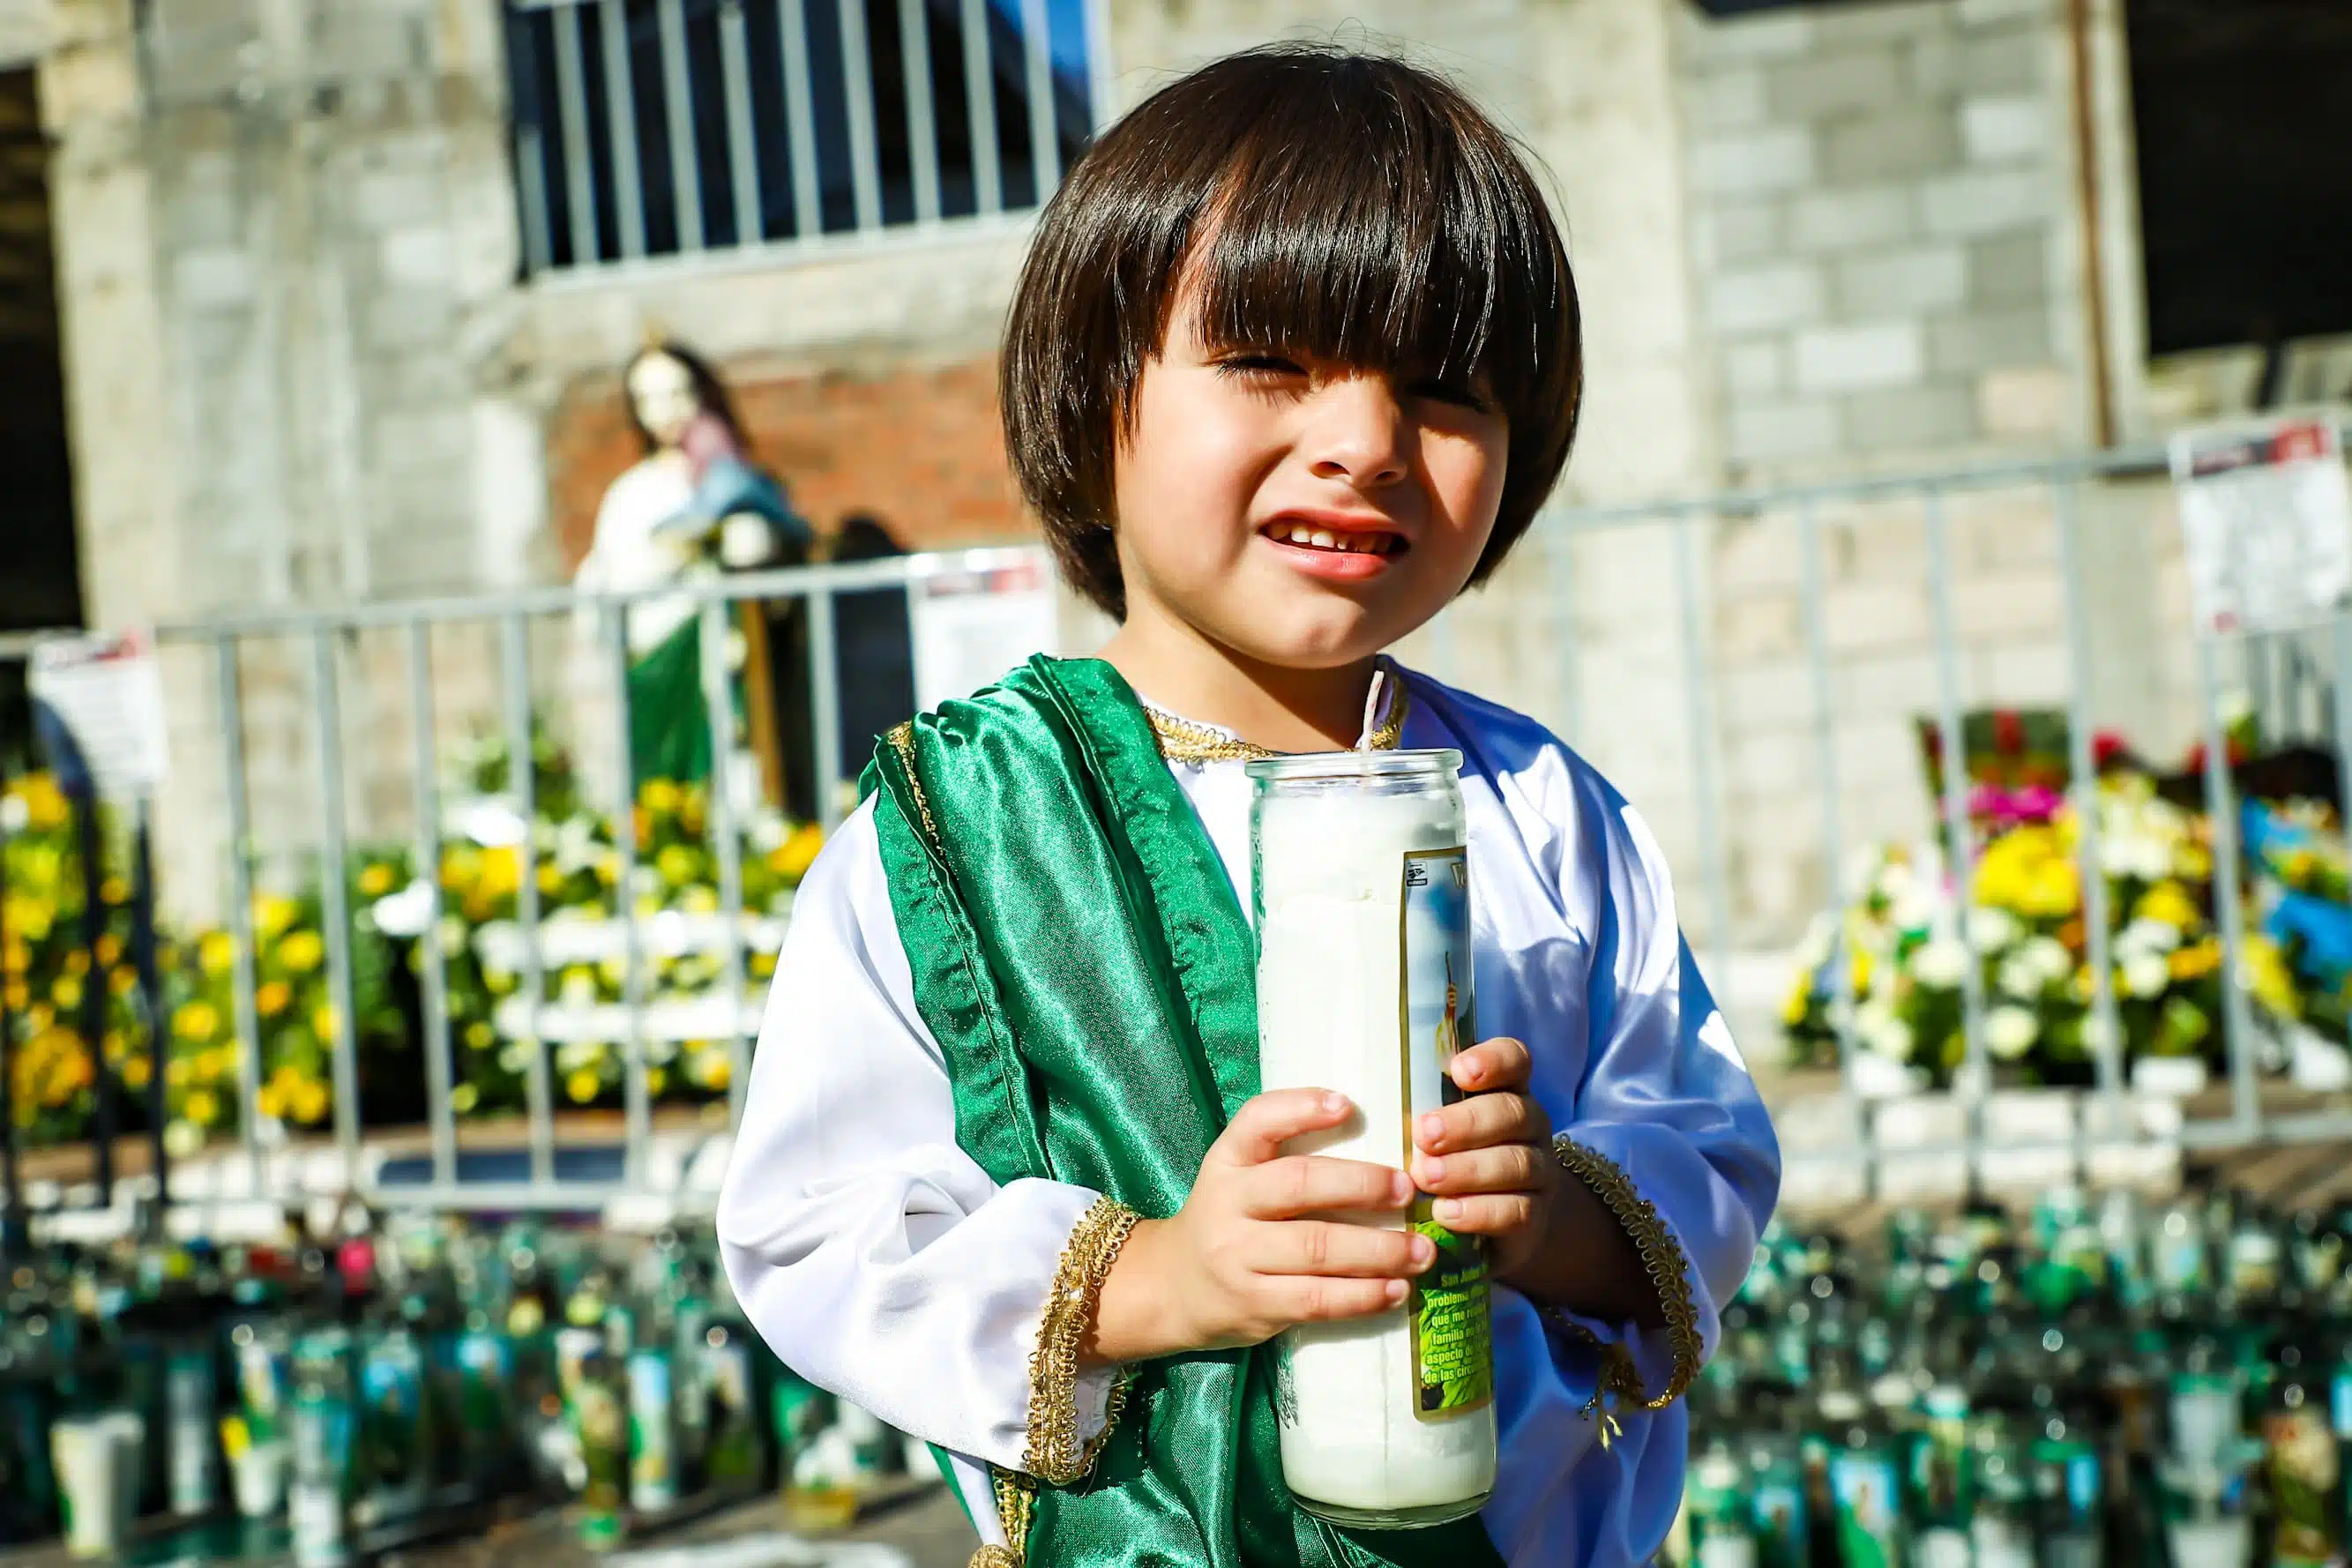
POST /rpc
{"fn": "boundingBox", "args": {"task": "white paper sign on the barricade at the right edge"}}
[2171,418,2352,637]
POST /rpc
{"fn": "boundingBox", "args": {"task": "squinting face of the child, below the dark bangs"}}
[1115,287,1510,670]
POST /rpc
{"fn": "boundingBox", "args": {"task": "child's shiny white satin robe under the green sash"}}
[717,675,1781,1568]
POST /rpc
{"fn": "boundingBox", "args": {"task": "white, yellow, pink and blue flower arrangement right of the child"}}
[1783,713,2352,1091]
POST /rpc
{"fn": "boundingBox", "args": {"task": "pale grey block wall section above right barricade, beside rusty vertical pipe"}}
[1682,0,2087,474]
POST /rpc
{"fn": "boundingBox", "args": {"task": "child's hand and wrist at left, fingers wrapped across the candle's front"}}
[1084,1088,1437,1363]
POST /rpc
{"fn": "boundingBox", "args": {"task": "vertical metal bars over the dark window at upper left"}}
[505,0,1108,273]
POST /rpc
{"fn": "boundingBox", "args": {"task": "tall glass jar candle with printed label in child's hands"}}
[1249,750,1496,1528]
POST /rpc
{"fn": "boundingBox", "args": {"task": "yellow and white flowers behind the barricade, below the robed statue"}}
[0,735,823,1154]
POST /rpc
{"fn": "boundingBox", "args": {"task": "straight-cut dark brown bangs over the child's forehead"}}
[1194,71,1566,402]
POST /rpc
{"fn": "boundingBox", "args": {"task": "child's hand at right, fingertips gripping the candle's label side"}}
[1414,1039,1566,1281]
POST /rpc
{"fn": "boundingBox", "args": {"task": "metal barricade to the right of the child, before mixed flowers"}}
[1505,411,2352,1197]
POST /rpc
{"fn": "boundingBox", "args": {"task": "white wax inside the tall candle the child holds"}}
[1256,766,1494,1521]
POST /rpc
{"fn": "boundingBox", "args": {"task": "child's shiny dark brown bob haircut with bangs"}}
[997,45,1583,618]
